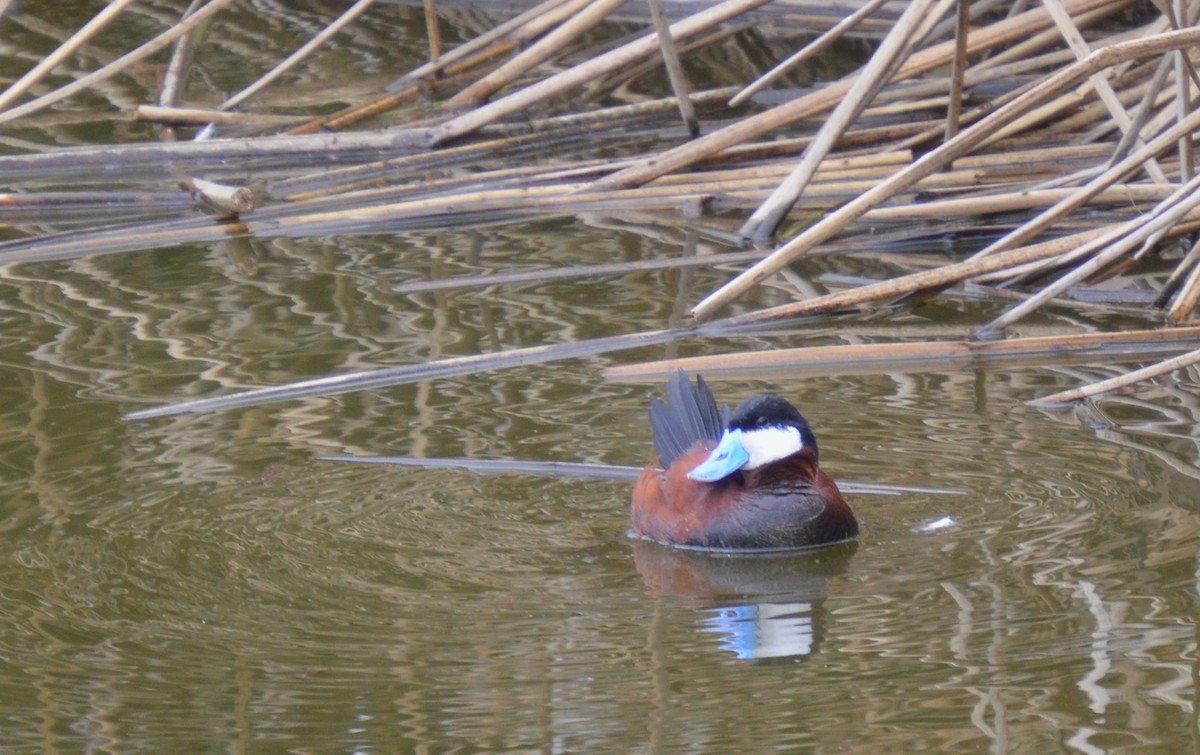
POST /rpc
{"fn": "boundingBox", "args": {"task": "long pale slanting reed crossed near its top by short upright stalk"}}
[430,0,767,145]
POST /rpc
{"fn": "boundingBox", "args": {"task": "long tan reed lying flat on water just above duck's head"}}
[602,320,1200,382]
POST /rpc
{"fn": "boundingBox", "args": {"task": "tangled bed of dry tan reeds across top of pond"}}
[0,0,1200,417]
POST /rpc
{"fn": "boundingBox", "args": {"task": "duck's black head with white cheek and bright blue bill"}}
[688,395,817,483]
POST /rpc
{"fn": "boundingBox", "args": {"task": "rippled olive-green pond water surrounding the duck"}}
[0,2,1200,753]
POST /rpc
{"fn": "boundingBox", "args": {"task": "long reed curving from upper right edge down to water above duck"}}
[692,29,1200,320]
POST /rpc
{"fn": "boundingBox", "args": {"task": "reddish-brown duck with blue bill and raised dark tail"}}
[631,370,858,552]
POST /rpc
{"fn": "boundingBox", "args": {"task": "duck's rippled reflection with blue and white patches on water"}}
[634,540,858,659]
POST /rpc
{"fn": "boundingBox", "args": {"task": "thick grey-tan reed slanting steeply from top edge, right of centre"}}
[740,0,935,241]
